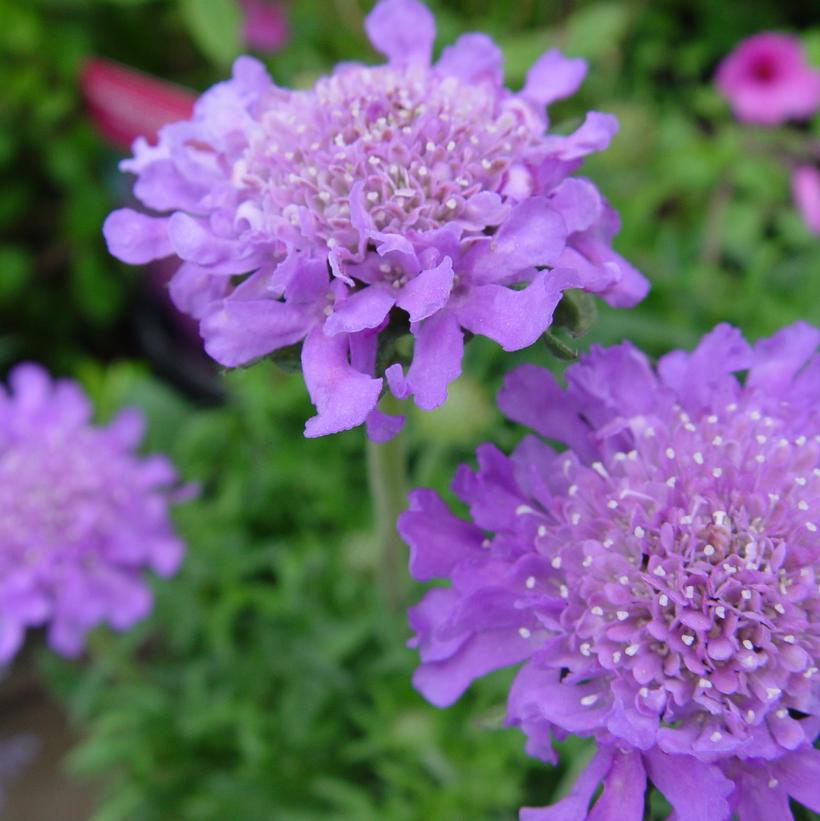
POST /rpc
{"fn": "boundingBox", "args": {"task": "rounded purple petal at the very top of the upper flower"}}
[364,0,436,65]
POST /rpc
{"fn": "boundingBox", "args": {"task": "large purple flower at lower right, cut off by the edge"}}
[399,323,820,821]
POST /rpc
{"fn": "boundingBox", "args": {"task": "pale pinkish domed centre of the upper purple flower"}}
[233,66,542,251]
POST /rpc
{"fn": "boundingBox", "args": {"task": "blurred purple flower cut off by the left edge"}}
[0,365,182,664]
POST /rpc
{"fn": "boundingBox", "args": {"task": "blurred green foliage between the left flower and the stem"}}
[44,366,555,821]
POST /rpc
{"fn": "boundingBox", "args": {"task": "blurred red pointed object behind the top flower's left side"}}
[80,57,196,151]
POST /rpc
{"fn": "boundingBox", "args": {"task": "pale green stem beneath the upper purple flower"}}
[367,396,407,611]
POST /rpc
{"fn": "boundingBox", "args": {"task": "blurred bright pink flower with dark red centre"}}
[716,32,820,125]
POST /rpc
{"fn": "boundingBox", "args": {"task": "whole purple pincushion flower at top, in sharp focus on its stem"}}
[104,0,647,438]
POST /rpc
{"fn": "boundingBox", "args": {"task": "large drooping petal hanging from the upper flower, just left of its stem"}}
[302,328,382,438]
